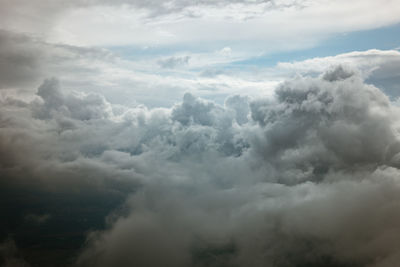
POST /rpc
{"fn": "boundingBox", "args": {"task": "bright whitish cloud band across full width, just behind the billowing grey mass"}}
[0,19,399,110]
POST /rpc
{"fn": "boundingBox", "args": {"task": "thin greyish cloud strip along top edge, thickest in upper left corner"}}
[0,0,294,43]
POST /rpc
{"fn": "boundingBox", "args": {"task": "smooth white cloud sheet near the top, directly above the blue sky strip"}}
[43,0,400,52]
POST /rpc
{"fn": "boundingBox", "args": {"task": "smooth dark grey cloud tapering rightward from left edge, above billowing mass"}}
[0,29,115,92]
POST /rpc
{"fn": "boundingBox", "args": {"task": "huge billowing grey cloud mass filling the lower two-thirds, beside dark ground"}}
[0,66,400,267]
